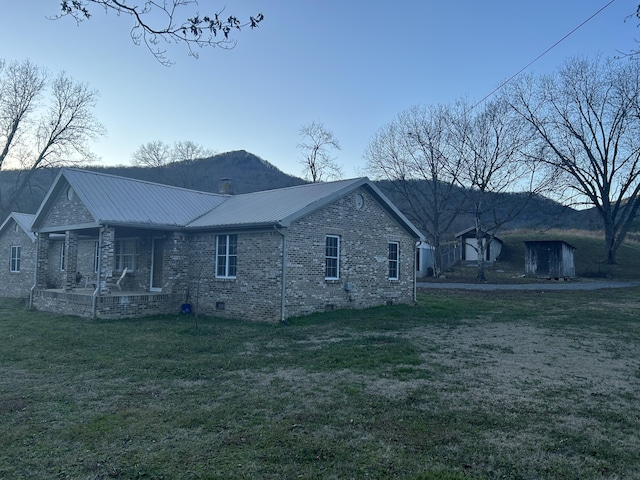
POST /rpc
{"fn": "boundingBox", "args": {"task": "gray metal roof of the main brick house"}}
[33,168,422,238]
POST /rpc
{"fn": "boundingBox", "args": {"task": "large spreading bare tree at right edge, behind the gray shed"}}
[510,58,640,264]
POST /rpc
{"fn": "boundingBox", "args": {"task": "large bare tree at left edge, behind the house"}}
[0,60,105,218]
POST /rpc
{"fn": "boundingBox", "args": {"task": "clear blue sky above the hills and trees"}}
[0,0,640,178]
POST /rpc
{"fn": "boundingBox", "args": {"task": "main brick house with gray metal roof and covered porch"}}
[30,169,422,321]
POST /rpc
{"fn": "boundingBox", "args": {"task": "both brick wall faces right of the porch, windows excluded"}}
[189,190,415,321]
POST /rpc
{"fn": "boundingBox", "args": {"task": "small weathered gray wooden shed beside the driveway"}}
[524,240,576,278]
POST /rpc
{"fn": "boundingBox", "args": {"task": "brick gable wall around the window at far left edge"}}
[0,222,36,298]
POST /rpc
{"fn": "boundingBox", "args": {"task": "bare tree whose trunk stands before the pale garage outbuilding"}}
[452,97,552,282]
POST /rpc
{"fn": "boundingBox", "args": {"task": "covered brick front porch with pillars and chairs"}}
[31,226,187,319]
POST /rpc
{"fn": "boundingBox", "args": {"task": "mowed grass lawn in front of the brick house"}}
[0,288,640,480]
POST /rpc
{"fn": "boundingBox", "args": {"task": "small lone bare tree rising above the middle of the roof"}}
[298,121,342,183]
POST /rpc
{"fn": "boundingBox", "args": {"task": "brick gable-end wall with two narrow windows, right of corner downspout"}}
[287,190,415,316]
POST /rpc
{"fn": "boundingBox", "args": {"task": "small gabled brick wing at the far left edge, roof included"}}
[0,212,36,298]
